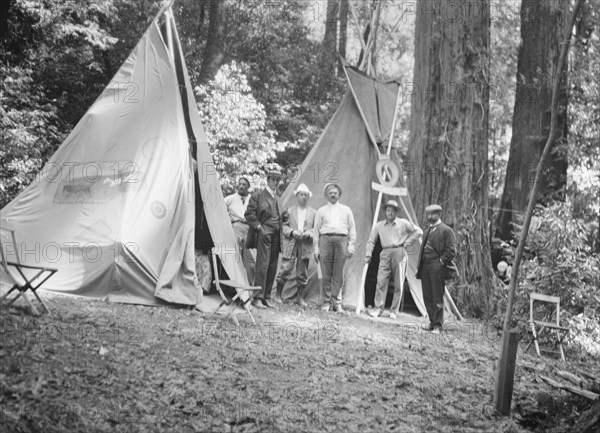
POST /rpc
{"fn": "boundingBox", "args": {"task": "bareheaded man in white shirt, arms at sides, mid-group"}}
[314,183,356,313]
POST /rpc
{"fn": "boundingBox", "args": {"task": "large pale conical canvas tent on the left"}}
[0,6,247,305]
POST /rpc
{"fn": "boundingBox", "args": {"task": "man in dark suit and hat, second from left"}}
[244,170,282,308]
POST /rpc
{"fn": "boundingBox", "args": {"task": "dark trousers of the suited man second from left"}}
[254,231,281,299]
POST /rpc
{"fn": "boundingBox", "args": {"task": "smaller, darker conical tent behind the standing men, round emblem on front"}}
[282,60,460,318]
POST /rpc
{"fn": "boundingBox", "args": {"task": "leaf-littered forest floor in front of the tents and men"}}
[0,294,600,433]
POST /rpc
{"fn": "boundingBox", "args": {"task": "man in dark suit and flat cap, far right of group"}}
[417,204,456,334]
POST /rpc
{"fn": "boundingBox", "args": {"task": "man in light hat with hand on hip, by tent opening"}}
[365,200,423,319]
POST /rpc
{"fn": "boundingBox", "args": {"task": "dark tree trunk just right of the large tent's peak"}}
[198,0,225,84]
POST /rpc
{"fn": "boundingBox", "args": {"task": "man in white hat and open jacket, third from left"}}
[275,183,317,307]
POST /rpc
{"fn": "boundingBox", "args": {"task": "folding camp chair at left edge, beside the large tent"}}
[0,220,58,316]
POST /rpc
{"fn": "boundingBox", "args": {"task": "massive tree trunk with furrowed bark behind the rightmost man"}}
[405,0,495,316]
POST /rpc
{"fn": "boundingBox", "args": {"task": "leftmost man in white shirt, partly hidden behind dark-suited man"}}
[225,177,256,284]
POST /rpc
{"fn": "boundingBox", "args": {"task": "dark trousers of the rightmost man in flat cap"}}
[421,258,446,328]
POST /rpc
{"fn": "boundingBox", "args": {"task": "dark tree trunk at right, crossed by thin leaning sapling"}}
[496,0,570,240]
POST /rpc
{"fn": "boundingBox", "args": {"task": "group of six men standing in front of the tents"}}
[225,170,456,333]
